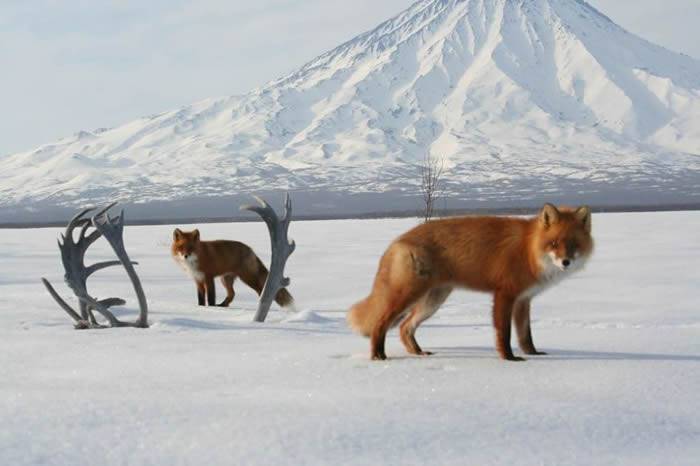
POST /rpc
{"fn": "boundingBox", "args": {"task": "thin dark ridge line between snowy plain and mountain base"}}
[0,203,700,230]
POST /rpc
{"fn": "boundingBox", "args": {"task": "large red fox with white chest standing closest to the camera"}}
[348,204,593,361]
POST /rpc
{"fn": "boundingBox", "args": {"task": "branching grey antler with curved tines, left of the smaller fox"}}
[41,203,148,329]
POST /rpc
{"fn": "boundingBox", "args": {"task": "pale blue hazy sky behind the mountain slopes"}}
[0,0,700,155]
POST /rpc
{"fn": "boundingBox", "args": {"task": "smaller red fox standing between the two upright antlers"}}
[171,229,294,307]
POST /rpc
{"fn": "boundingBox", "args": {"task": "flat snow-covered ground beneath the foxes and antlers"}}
[0,212,700,466]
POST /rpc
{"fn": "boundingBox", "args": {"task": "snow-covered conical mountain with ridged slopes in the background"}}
[0,0,700,219]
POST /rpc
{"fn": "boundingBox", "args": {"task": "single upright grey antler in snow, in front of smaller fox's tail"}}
[241,194,296,322]
